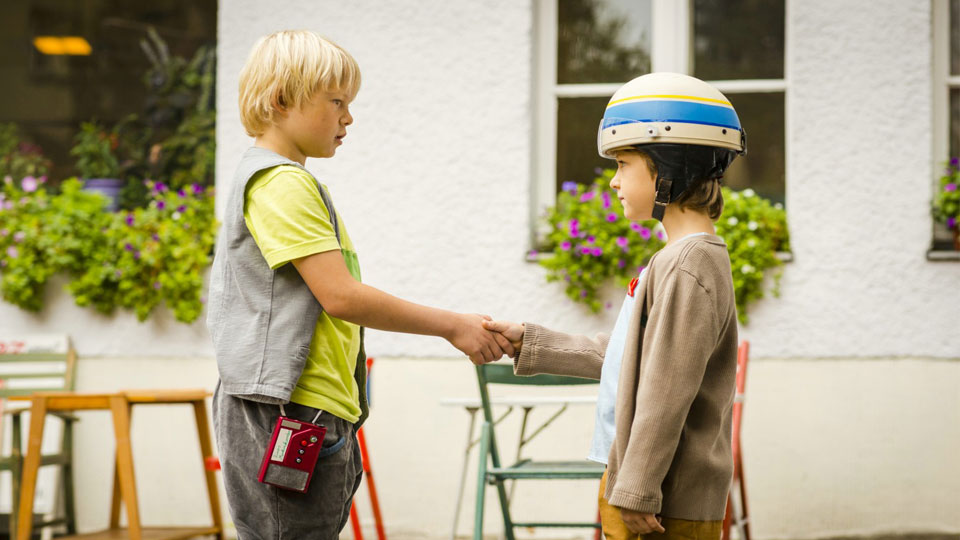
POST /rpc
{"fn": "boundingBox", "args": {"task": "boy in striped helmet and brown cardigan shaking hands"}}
[484,73,746,539]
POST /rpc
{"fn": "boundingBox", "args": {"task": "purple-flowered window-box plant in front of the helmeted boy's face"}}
[539,173,664,313]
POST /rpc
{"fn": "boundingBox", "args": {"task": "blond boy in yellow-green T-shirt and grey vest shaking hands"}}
[207,31,514,540]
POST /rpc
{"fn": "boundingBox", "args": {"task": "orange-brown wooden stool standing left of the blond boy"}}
[17,390,224,540]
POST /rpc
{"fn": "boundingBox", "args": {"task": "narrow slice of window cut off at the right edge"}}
[931,0,960,250]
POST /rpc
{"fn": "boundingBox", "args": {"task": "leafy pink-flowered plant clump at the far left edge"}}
[0,176,109,311]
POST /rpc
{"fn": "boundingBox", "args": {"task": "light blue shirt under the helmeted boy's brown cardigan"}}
[587,233,706,465]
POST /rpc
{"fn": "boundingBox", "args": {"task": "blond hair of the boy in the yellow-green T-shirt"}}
[240,30,360,137]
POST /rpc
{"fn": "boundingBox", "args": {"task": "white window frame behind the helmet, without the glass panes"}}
[530,0,790,246]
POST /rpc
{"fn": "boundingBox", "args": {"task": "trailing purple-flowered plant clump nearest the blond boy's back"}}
[69,183,217,323]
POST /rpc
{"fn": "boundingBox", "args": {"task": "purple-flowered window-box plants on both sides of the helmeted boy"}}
[539,173,790,324]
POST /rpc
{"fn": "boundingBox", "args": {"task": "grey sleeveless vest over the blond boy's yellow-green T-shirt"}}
[207,146,369,426]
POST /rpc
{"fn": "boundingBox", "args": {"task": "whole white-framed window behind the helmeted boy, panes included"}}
[534,0,788,234]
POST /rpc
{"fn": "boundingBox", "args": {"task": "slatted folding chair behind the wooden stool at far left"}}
[0,335,77,538]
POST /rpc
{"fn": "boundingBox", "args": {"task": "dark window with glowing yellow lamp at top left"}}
[0,0,217,181]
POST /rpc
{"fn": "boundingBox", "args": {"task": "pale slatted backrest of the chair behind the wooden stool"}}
[0,334,77,398]
